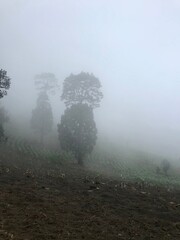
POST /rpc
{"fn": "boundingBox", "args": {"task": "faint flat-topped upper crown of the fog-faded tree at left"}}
[35,73,58,93]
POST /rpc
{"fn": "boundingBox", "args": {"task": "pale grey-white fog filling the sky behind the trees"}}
[0,0,180,159]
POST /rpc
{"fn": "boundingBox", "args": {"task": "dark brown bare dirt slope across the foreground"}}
[0,160,180,240]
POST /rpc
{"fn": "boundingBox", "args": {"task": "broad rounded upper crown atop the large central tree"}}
[61,72,103,108]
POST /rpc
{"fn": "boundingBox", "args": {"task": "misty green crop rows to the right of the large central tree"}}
[87,143,180,187]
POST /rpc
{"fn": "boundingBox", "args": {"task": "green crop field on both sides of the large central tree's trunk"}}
[0,139,180,187]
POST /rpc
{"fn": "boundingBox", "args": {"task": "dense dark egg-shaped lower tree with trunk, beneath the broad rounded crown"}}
[58,103,97,165]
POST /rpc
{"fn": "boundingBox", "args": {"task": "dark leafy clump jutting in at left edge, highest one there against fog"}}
[0,69,11,98]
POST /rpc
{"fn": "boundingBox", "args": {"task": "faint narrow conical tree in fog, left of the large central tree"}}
[31,92,53,144]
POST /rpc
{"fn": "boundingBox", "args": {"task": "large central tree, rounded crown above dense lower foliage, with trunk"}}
[58,72,103,165]
